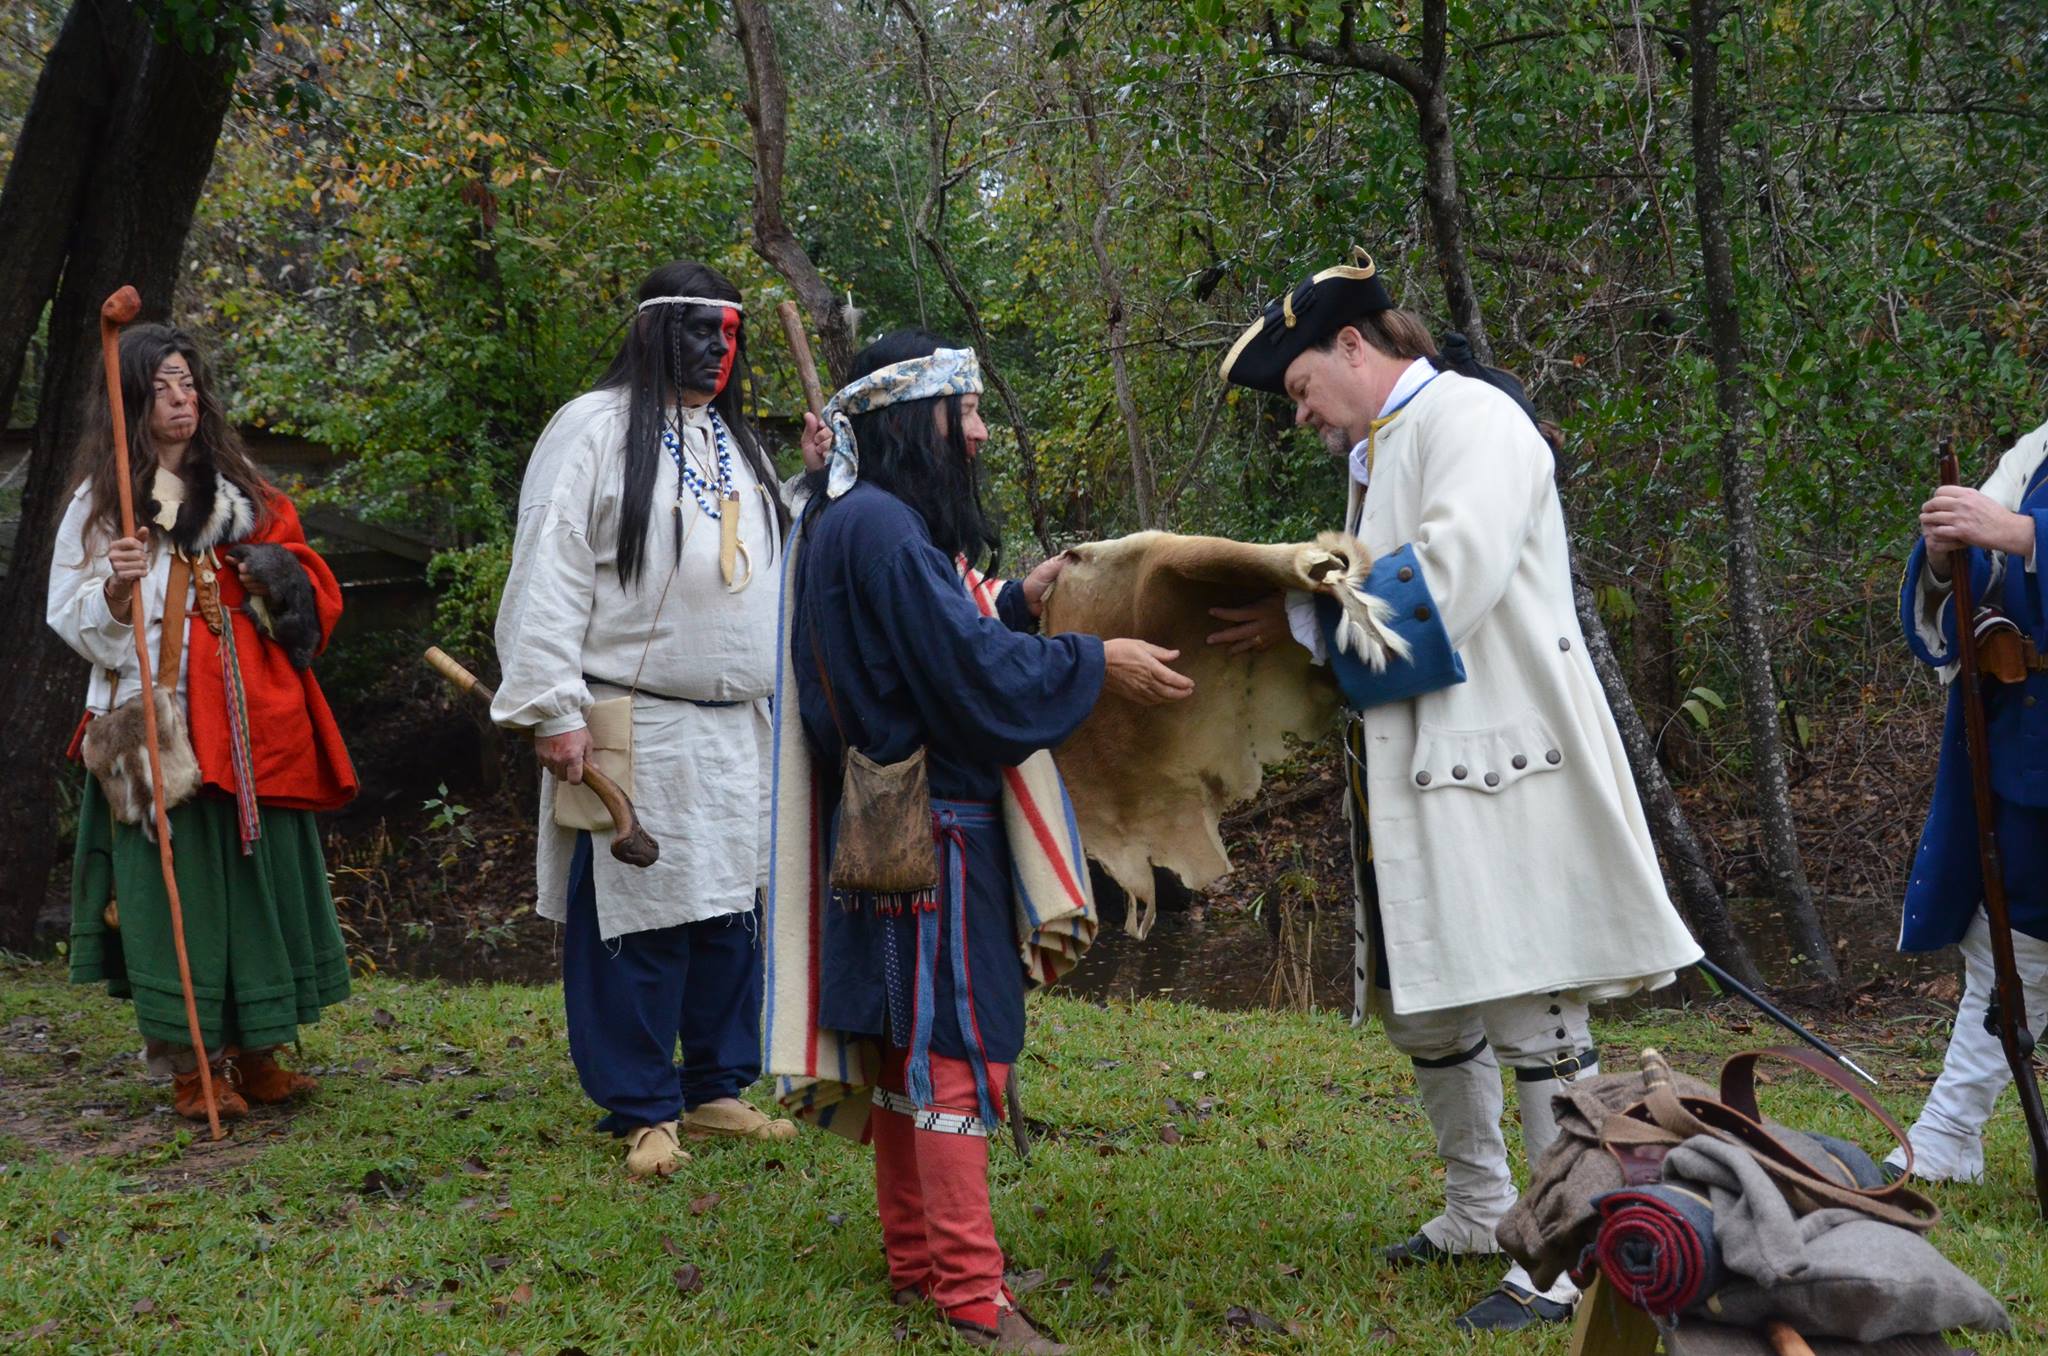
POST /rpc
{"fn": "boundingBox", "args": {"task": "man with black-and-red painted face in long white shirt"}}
[492,262,829,1176]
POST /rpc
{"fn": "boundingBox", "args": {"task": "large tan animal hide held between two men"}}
[1042,533,1407,936]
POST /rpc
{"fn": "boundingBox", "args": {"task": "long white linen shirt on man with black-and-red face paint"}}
[492,391,780,940]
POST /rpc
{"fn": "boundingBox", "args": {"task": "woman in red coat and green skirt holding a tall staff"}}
[47,326,356,1118]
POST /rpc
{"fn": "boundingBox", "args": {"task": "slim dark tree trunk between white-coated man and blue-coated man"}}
[1690,0,1841,987]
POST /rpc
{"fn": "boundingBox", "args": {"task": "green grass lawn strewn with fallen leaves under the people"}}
[0,967,2048,1356]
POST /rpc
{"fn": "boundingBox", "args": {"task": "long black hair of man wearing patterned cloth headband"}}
[809,330,1004,574]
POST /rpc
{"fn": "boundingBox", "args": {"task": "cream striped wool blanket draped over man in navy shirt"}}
[762,516,1096,1139]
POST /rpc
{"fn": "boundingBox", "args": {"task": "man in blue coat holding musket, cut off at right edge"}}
[1886,424,2048,1182]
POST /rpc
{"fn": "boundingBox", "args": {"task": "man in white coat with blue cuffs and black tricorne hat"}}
[1210,252,1700,1329]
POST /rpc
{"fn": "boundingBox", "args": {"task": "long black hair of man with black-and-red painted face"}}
[598,258,788,588]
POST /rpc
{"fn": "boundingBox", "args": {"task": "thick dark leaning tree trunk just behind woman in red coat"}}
[0,6,238,950]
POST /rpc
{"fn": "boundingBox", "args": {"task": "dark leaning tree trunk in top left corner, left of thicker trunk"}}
[0,0,137,436]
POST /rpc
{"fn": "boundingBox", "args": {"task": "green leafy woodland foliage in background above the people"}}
[72,0,2048,772]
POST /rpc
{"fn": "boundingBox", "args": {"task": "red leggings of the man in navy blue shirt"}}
[868,1043,1010,1327]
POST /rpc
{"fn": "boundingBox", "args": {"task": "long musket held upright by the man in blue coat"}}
[1942,438,2048,1219]
